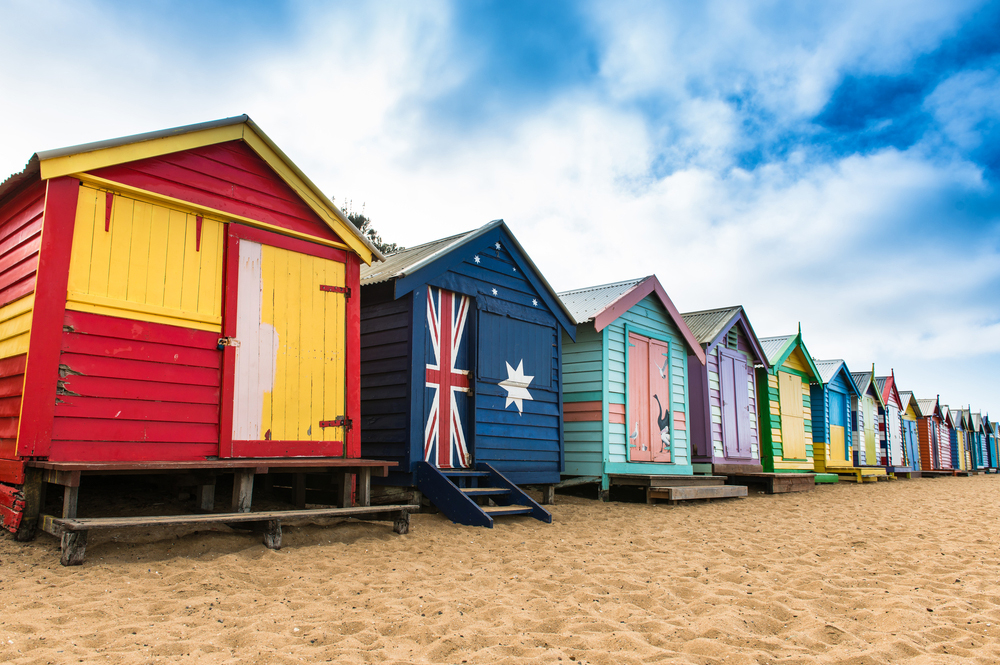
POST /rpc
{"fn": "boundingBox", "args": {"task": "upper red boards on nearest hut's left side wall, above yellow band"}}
[0,182,45,307]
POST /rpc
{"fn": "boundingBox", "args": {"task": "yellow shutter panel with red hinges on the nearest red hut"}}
[66,186,225,332]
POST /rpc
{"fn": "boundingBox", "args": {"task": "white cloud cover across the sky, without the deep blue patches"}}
[0,2,1000,401]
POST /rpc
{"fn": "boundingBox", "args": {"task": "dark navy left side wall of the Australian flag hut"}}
[361,282,413,466]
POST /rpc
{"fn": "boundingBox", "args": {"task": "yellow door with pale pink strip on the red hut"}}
[233,240,346,455]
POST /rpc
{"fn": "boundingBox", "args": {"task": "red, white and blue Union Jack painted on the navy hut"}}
[424,287,470,469]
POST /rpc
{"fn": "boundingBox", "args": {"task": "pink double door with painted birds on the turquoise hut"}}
[628,333,671,462]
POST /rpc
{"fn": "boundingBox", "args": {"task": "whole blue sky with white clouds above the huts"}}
[0,0,1000,410]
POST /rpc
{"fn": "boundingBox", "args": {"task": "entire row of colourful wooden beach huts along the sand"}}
[0,116,997,546]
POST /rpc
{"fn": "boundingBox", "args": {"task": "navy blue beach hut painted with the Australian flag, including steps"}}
[361,220,576,526]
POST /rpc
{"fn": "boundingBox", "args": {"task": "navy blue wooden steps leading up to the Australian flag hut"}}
[416,462,552,529]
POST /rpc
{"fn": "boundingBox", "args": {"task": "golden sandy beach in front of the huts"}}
[0,476,1000,665]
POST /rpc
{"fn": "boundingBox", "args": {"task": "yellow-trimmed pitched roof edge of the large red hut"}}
[0,115,383,263]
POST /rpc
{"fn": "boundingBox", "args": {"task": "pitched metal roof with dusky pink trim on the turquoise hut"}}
[559,275,705,365]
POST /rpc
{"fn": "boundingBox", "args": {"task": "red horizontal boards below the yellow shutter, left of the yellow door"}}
[49,311,222,461]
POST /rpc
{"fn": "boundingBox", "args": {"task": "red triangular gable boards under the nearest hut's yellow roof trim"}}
[92,141,341,242]
